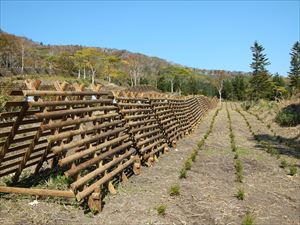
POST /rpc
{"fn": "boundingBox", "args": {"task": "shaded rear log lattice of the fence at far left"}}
[0,81,49,179]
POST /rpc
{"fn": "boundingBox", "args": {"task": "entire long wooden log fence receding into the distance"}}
[0,80,217,211]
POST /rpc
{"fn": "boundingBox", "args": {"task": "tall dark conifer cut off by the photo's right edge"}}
[289,41,300,91]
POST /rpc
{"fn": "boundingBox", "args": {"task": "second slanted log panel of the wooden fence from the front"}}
[115,92,168,166]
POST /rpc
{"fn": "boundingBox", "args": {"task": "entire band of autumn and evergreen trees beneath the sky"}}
[0,31,300,100]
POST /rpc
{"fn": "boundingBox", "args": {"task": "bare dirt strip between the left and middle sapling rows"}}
[163,104,245,224]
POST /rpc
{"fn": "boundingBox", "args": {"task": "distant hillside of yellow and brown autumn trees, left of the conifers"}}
[0,31,247,94]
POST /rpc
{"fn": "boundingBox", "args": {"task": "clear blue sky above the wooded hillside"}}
[0,0,300,75]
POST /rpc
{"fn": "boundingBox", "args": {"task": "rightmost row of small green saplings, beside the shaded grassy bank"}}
[236,107,297,176]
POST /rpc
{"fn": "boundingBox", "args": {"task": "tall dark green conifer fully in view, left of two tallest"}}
[250,41,272,100]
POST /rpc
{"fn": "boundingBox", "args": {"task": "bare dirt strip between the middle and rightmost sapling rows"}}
[230,104,300,225]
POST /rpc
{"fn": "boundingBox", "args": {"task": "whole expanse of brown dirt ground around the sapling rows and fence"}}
[0,103,300,225]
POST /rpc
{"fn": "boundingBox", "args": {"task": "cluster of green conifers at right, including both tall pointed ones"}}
[220,41,300,101]
